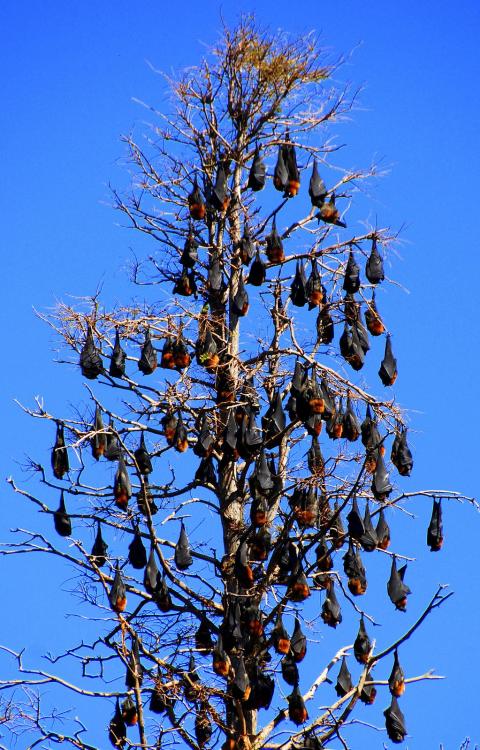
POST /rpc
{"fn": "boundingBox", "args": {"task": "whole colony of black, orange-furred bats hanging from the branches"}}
[52,142,443,750]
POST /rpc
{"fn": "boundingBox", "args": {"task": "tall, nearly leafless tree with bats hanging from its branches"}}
[2,19,472,750]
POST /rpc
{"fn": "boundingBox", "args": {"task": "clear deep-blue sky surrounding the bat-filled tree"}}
[0,0,480,750]
